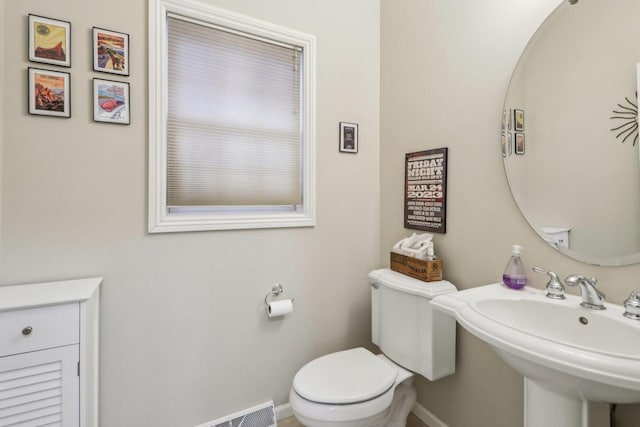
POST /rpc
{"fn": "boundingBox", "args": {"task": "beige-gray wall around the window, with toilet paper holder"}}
[0,0,380,427]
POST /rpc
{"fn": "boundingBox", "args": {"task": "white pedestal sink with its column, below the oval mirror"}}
[432,283,640,427]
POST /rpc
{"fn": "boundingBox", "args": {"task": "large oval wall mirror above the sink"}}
[501,0,640,266]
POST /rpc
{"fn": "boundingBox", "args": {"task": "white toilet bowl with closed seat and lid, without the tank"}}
[289,348,416,427]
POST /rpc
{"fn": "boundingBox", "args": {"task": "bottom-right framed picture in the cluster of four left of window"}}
[93,79,131,125]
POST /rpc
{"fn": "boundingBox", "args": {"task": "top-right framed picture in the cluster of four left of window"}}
[93,27,129,76]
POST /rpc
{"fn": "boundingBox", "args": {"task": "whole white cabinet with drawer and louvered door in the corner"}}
[0,278,102,427]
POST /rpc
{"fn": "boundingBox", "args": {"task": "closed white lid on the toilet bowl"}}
[293,348,398,404]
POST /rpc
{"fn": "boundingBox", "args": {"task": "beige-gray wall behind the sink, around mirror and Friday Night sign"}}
[380,0,640,427]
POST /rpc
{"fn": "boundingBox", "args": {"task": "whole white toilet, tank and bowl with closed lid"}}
[289,269,456,427]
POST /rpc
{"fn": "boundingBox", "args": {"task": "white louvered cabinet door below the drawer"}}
[0,344,80,427]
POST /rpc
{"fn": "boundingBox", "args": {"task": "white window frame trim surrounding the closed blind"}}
[149,0,316,233]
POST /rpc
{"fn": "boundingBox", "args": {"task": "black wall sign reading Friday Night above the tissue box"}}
[404,148,448,233]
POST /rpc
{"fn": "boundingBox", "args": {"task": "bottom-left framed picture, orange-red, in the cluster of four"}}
[28,67,71,118]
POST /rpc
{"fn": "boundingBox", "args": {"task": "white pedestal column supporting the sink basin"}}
[524,377,589,427]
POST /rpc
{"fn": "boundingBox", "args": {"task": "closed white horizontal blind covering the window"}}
[166,14,303,210]
